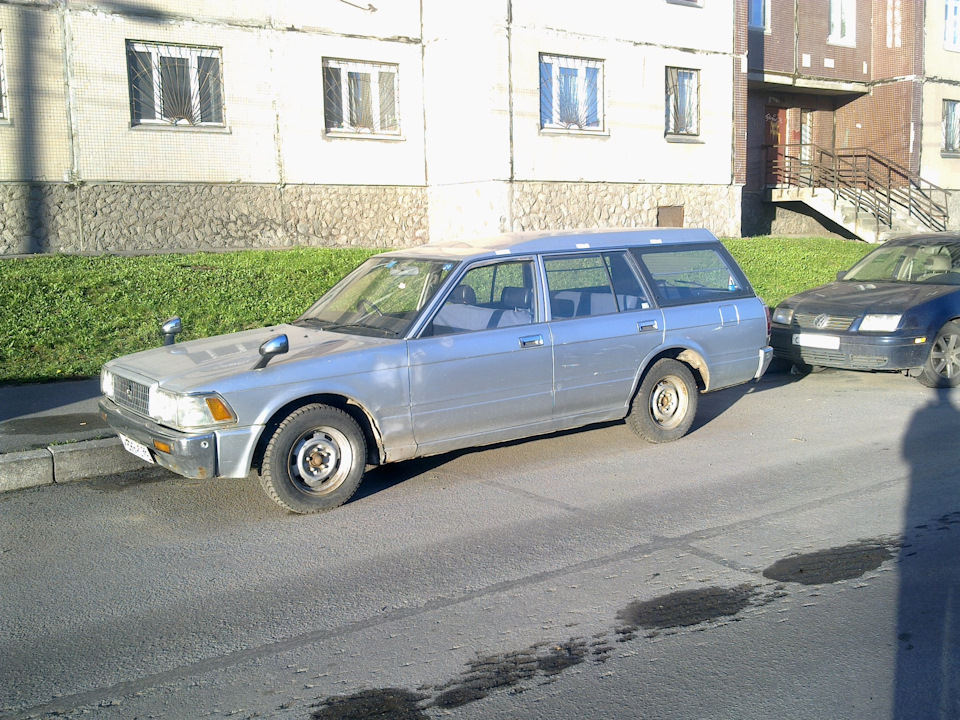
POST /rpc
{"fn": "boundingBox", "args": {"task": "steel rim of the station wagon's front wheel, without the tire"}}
[288,427,353,495]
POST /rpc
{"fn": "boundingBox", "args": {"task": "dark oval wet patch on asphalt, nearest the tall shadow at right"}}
[763,541,893,585]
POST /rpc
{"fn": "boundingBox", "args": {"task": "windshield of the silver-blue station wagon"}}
[295,256,457,337]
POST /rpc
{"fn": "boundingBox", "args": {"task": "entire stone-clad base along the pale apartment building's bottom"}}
[0,182,740,255]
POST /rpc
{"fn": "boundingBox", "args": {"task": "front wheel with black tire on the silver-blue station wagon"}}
[260,404,367,514]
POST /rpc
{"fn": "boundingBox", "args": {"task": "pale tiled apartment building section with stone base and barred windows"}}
[0,0,745,255]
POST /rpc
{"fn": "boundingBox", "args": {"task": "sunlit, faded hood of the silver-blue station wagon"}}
[106,325,397,392]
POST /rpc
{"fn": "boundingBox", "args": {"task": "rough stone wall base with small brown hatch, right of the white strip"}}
[512,182,740,237]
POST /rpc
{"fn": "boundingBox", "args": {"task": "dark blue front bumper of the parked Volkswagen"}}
[770,326,930,370]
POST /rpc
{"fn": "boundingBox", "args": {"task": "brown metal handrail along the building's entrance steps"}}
[764,143,949,231]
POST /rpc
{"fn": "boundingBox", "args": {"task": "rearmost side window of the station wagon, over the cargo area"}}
[632,245,753,305]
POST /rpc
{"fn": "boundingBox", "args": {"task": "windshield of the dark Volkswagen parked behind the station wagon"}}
[843,241,960,285]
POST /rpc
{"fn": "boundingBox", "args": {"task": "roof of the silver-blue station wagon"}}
[387,228,718,260]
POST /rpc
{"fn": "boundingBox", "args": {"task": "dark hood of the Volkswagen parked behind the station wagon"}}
[784,280,958,315]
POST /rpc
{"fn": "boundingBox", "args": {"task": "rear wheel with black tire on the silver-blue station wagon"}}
[627,358,700,443]
